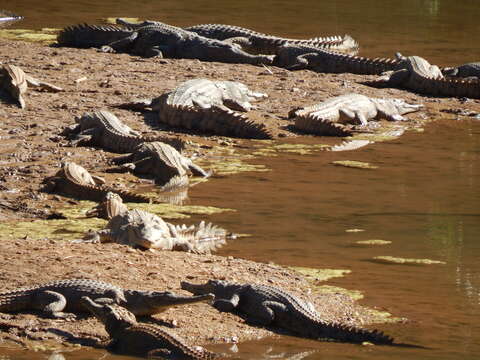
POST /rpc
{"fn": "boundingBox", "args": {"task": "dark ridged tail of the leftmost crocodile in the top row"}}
[57,24,132,48]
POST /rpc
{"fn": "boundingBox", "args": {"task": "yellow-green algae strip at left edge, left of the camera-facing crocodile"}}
[0,218,106,240]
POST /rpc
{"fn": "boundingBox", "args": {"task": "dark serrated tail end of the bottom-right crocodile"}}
[316,323,393,345]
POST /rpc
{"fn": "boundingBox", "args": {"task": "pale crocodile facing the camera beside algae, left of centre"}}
[80,196,235,254]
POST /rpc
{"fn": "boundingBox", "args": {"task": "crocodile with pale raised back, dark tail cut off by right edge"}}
[364,53,480,99]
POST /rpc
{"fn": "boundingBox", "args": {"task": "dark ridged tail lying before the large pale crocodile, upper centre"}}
[160,105,273,139]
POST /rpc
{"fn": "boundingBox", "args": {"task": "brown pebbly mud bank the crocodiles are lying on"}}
[0,40,480,348]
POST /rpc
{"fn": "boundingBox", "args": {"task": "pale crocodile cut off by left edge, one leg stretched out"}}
[0,64,63,109]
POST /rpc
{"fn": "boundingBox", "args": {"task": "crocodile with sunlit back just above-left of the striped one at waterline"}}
[62,110,184,153]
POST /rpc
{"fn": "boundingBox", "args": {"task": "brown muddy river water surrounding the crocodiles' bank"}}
[2,0,480,360]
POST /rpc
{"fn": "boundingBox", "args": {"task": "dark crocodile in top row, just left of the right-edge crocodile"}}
[273,43,403,75]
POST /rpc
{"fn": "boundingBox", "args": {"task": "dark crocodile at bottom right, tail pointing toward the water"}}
[181,280,393,345]
